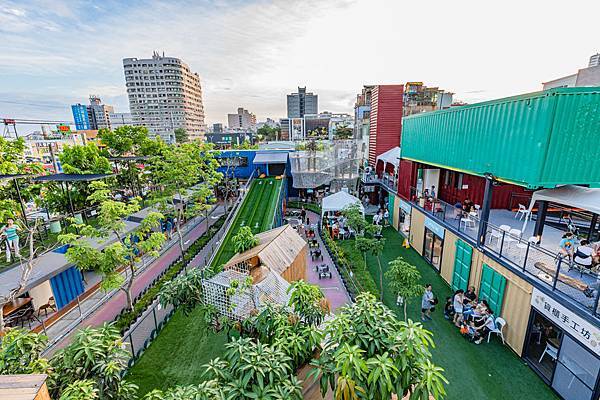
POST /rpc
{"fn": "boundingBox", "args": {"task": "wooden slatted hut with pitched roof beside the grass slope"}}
[223,225,308,283]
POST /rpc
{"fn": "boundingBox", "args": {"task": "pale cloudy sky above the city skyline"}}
[0,0,600,129]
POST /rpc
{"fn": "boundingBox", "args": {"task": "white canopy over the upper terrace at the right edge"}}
[523,185,600,230]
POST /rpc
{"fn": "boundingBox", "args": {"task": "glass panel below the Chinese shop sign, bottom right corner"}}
[552,336,600,400]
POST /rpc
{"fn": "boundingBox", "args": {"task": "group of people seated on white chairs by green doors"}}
[444,286,496,344]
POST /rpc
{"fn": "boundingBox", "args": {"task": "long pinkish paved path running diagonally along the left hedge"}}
[47,206,224,351]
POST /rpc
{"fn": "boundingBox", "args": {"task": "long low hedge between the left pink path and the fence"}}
[115,215,225,333]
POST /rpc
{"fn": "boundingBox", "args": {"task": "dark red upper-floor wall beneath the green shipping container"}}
[438,170,533,209]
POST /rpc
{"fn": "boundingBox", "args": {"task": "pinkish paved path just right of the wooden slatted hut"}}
[306,211,351,312]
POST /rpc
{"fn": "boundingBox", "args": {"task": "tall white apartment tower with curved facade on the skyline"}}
[123,52,205,142]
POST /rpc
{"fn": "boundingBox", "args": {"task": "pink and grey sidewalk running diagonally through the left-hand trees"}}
[41,205,224,353]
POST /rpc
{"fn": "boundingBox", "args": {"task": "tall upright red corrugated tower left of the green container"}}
[369,85,404,167]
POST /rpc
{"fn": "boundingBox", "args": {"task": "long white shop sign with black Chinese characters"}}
[531,288,600,355]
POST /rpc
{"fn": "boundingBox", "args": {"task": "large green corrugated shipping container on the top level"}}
[401,87,600,189]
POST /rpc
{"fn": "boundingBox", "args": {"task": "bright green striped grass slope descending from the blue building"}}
[212,178,281,266]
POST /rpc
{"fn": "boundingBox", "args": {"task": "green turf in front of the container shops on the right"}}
[356,227,558,400]
